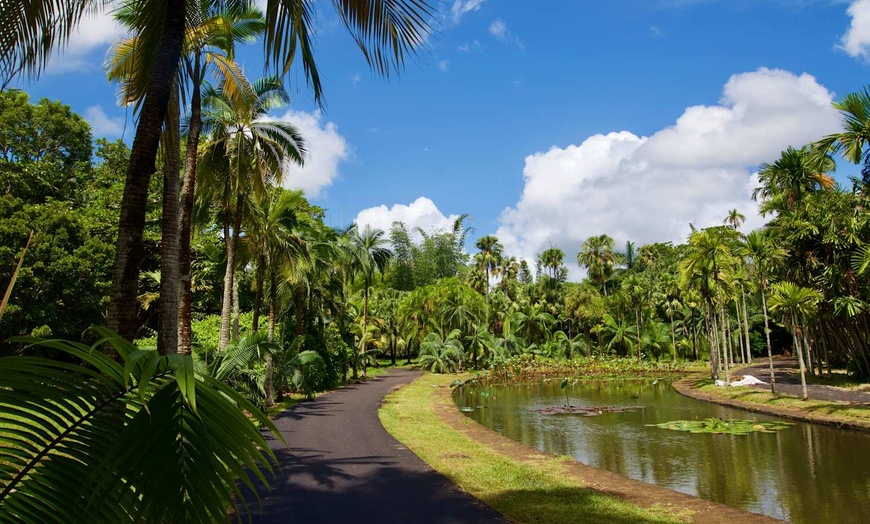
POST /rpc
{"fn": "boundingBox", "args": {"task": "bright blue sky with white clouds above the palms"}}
[15,0,870,270]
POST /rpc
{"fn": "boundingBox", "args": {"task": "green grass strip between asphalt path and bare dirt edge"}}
[380,375,684,523]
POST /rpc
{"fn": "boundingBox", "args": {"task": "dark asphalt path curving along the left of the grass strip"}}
[246,369,506,524]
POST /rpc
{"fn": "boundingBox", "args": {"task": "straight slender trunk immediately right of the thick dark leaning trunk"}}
[157,89,181,355]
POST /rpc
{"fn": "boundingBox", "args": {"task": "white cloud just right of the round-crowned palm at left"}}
[277,110,350,198]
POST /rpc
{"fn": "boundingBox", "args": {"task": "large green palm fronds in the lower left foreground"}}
[0,330,281,524]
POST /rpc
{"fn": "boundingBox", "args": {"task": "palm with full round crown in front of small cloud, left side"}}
[202,78,305,349]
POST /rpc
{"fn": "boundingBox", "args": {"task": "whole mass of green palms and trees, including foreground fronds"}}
[0,0,870,522]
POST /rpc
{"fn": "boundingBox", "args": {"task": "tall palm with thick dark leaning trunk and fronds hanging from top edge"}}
[0,0,434,340]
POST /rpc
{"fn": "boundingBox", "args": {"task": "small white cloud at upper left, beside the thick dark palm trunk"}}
[46,12,127,73]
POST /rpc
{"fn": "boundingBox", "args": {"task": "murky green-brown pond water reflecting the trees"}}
[454,380,870,523]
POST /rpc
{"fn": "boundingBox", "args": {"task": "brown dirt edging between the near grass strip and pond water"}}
[433,387,781,524]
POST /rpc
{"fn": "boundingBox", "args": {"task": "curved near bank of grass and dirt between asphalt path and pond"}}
[381,375,778,524]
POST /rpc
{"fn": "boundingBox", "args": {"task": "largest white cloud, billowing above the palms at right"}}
[496,69,840,278]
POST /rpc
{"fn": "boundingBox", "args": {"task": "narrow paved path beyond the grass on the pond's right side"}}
[732,358,870,406]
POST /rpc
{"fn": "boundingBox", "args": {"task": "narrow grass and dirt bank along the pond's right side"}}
[673,374,870,432]
